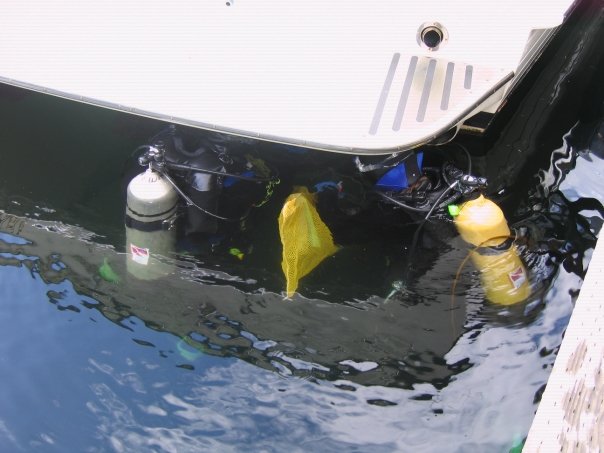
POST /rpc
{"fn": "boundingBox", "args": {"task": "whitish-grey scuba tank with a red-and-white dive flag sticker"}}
[126,169,178,280]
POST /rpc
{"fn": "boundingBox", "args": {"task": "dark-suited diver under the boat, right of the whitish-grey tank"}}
[129,125,279,259]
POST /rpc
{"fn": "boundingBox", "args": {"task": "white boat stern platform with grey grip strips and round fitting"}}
[0,0,572,154]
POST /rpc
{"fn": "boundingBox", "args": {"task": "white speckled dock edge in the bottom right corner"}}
[522,235,604,453]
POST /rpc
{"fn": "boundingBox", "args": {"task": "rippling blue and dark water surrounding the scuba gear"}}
[0,64,604,452]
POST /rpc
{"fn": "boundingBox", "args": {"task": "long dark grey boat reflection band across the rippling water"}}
[0,208,468,387]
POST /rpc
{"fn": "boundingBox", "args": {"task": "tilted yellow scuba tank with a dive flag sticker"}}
[455,195,531,305]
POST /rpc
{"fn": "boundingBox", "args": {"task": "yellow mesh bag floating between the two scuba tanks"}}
[279,187,337,297]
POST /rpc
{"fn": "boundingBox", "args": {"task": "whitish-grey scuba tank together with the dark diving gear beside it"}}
[125,125,279,280]
